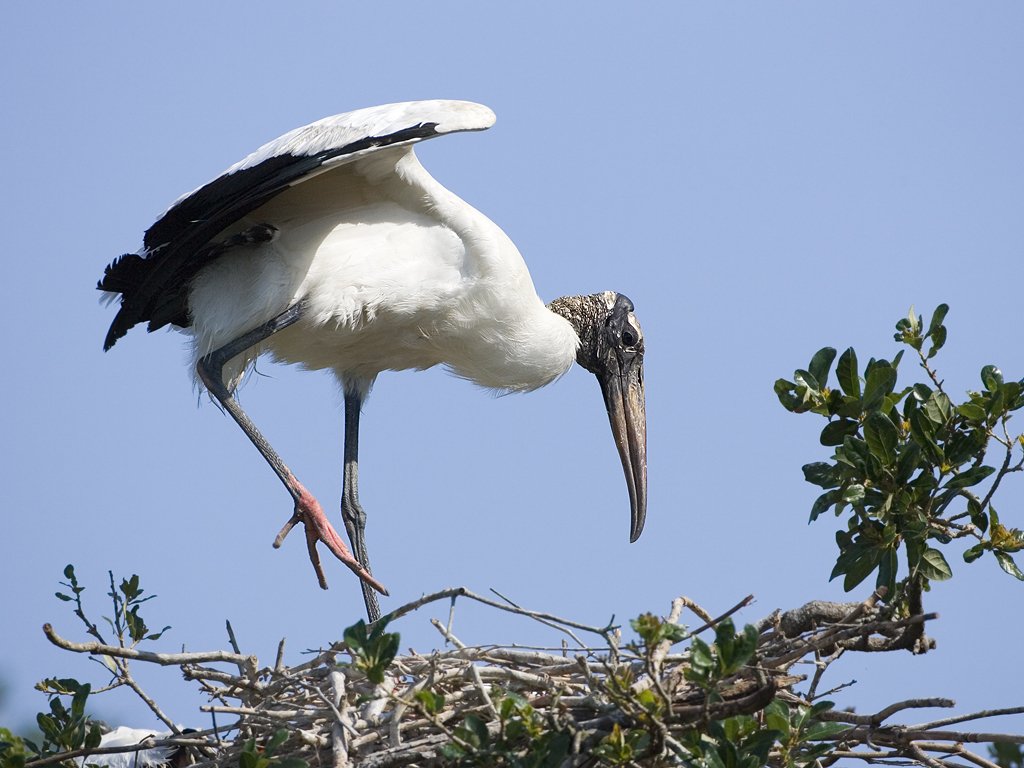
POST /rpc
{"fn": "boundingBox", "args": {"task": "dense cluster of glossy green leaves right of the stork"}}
[775,304,1024,600]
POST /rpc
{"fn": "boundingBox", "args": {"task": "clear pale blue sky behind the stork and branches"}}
[0,1,1024,732]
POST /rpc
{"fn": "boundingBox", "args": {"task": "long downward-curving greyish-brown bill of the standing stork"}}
[598,362,647,542]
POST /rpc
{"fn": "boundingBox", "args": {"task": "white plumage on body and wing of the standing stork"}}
[188,102,580,393]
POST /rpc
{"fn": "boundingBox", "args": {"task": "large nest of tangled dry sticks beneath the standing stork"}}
[41,589,1024,768]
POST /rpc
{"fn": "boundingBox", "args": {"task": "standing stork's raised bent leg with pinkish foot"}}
[196,303,387,595]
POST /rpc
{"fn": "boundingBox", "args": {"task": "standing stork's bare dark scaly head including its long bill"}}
[548,291,647,542]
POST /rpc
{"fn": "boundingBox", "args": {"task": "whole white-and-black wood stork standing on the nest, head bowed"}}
[98,100,647,620]
